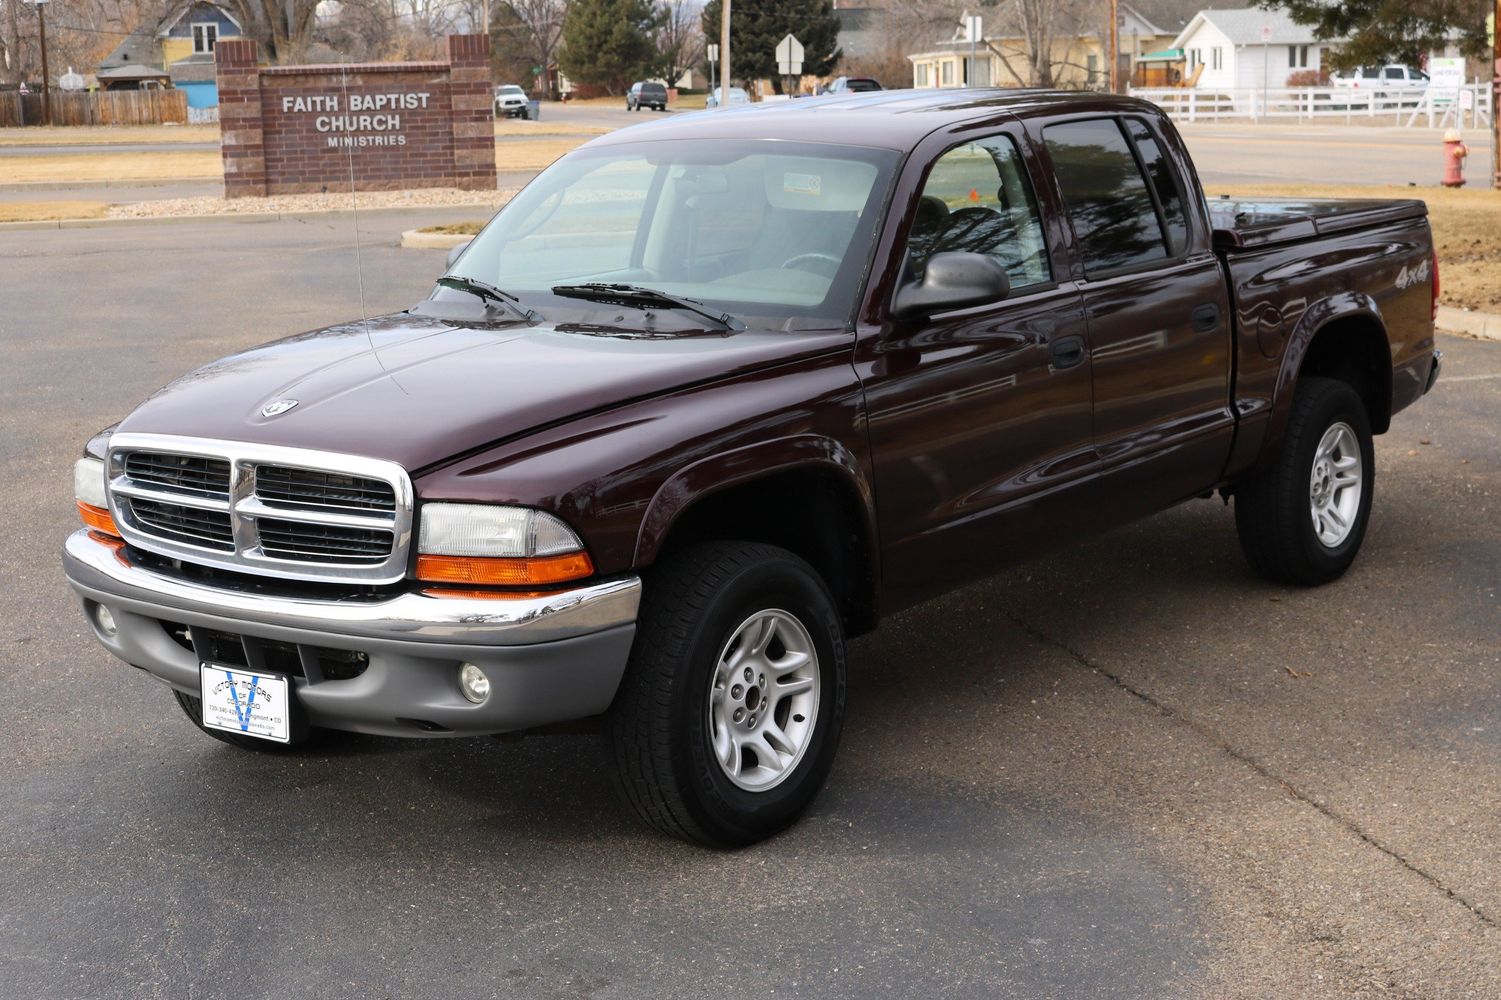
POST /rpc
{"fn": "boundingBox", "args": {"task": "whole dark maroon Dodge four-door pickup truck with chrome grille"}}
[65,90,1439,844]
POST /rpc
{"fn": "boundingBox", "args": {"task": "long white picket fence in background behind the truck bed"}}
[1130,84,1490,128]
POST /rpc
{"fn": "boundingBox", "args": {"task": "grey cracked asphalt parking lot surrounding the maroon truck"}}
[0,210,1501,1000]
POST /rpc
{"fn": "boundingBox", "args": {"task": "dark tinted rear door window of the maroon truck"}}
[1043,119,1187,275]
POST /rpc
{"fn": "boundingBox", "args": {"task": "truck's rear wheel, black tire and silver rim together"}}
[1235,378,1376,587]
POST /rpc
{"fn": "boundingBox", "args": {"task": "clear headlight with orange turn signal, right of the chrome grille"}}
[417,503,594,586]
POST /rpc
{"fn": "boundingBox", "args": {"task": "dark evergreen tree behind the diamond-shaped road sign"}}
[704,0,841,93]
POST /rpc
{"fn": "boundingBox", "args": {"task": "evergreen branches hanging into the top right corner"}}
[1260,0,1490,69]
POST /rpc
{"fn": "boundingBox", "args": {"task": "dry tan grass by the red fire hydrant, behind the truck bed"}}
[1205,185,1501,312]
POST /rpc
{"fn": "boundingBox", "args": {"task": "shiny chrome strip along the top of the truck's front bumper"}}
[63,530,641,646]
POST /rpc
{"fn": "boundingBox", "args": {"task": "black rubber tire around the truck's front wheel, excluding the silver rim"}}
[605,542,845,847]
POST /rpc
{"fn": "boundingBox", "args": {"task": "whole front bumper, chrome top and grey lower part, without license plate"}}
[63,530,641,736]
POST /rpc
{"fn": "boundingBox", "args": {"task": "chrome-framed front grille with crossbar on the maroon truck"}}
[108,434,413,583]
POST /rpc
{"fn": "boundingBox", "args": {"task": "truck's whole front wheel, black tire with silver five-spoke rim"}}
[606,542,845,847]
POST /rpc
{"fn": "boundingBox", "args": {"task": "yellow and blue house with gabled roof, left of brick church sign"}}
[96,0,243,108]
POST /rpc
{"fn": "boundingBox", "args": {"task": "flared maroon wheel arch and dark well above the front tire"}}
[635,435,880,635]
